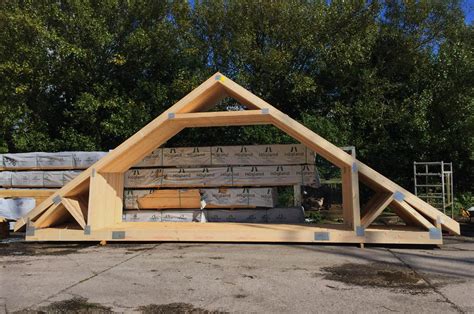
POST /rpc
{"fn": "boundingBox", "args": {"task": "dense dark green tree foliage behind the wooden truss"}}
[0,0,474,190]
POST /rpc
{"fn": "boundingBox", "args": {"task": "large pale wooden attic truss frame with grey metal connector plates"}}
[15,73,459,244]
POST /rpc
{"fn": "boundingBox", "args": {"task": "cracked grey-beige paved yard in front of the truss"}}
[0,237,474,313]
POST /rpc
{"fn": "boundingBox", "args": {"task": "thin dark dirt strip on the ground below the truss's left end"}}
[0,242,92,256]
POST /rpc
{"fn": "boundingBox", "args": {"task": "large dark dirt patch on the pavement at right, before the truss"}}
[322,263,430,292]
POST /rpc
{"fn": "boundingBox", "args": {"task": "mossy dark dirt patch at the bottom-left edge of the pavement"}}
[26,298,113,313]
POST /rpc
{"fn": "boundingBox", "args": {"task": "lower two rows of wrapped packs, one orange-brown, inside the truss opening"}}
[122,188,304,223]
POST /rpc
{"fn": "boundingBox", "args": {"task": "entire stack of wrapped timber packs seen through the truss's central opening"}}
[123,144,319,223]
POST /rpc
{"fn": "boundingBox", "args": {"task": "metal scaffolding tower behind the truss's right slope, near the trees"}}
[413,161,454,217]
